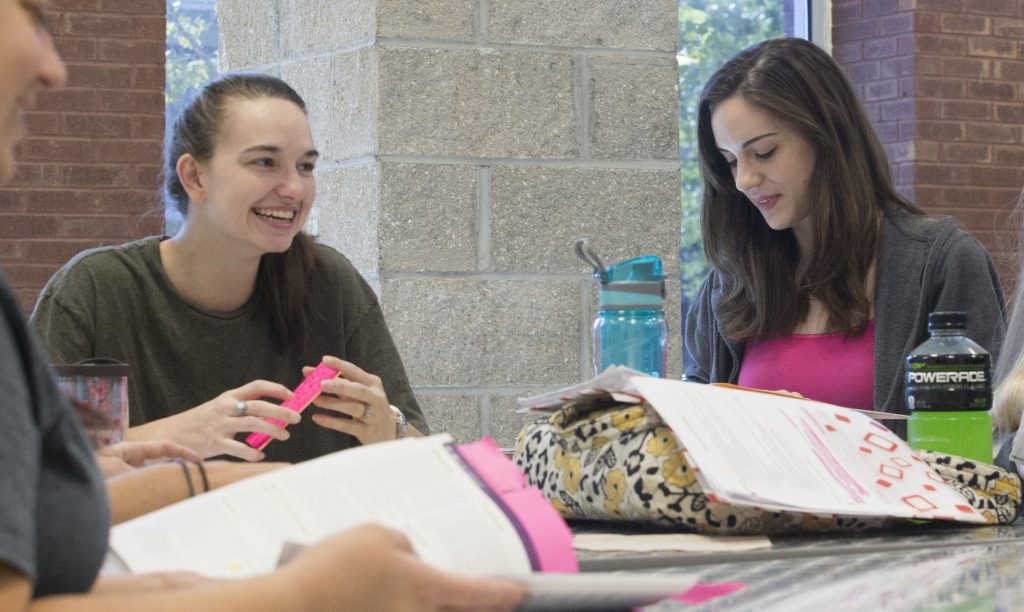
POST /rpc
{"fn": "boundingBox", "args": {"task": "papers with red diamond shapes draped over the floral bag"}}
[520,368,986,523]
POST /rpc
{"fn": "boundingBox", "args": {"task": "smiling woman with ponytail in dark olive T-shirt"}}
[32,74,427,462]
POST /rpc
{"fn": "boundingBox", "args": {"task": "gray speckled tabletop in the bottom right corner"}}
[578,523,1024,612]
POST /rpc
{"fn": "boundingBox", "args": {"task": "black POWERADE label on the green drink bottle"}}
[906,354,992,411]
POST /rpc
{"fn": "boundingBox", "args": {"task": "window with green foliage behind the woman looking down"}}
[677,0,829,368]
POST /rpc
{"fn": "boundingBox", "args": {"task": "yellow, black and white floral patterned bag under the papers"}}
[513,396,1021,534]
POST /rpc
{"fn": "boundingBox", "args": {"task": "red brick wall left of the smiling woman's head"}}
[0,0,166,313]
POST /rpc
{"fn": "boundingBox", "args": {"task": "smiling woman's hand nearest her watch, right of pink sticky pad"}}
[302,355,418,444]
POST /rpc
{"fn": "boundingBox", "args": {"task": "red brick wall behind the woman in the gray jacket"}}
[833,0,1024,292]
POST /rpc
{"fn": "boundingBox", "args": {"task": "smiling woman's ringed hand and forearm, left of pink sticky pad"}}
[128,381,300,462]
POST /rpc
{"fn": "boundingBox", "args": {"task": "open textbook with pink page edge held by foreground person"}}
[111,435,695,609]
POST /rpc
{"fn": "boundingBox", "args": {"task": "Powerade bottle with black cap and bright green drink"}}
[906,312,992,464]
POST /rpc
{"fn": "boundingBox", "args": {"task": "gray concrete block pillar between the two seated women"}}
[218,0,681,445]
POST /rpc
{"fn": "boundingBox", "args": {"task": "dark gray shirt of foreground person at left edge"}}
[0,274,111,597]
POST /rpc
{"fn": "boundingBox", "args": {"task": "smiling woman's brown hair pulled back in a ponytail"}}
[163,73,321,355]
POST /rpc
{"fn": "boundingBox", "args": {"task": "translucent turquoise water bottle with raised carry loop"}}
[575,238,669,378]
